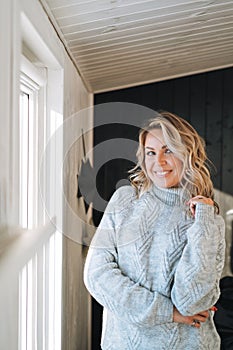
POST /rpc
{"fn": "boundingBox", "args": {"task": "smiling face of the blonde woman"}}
[144,129,183,188]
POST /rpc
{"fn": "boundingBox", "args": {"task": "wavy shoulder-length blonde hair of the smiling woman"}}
[129,111,218,211]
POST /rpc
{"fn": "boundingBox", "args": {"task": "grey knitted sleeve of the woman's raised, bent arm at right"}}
[171,203,225,316]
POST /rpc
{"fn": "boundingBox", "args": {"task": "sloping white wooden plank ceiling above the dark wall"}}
[40,0,233,93]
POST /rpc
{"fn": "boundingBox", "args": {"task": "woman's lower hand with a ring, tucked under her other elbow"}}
[173,306,210,328]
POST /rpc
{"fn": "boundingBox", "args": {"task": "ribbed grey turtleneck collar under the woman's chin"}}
[150,185,190,206]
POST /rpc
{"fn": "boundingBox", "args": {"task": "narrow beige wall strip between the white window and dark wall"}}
[62,53,92,350]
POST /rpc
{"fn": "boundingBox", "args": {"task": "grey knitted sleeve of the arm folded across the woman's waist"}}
[84,187,173,327]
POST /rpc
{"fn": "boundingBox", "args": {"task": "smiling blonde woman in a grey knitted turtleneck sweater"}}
[84,112,225,350]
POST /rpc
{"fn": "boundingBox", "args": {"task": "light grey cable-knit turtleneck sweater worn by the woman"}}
[84,186,225,350]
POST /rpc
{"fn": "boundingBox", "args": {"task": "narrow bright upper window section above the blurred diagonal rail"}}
[19,73,41,229]
